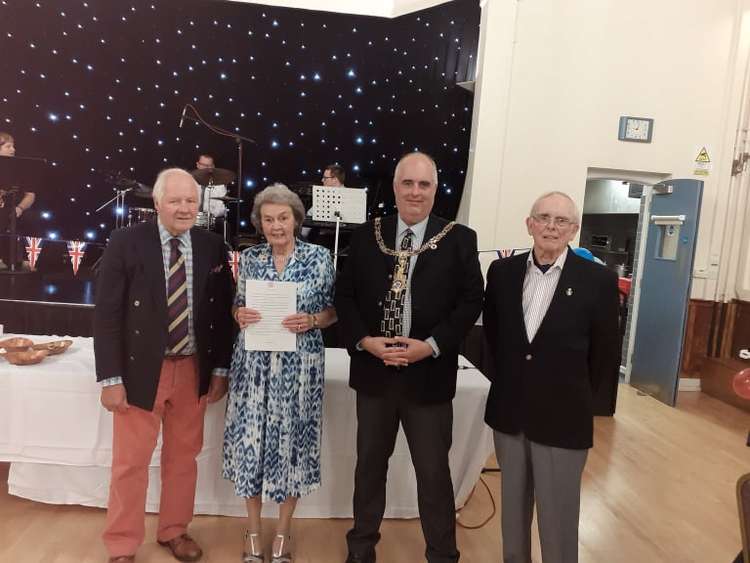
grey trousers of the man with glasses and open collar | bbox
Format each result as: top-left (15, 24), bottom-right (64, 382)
top-left (495, 432), bottom-right (588, 563)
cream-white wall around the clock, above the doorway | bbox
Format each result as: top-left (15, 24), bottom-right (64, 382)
top-left (459, 0), bottom-right (747, 299)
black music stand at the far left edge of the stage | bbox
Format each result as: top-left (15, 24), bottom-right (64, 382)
top-left (0, 156), bottom-right (47, 274)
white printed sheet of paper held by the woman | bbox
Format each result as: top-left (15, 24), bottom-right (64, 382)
top-left (245, 280), bottom-right (297, 352)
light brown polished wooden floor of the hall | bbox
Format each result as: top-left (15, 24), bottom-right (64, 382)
top-left (0, 386), bottom-right (750, 563)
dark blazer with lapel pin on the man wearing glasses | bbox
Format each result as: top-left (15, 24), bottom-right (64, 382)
top-left (483, 250), bottom-right (620, 449)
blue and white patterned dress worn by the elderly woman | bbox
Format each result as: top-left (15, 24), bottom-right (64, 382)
top-left (223, 239), bottom-right (335, 502)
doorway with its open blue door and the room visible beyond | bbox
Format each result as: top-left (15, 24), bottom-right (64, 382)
top-left (580, 169), bottom-right (703, 405)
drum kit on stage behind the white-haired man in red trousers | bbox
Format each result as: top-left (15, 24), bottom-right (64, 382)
top-left (97, 168), bottom-right (242, 240)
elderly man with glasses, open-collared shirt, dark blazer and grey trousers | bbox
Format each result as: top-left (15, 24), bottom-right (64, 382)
top-left (483, 192), bottom-right (619, 563)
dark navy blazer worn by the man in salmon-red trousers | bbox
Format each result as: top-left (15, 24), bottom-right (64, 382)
top-left (94, 223), bottom-right (233, 410)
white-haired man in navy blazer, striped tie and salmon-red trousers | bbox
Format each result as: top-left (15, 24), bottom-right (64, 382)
top-left (94, 168), bottom-right (233, 563)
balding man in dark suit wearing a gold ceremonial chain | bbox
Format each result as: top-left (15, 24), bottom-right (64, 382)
top-left (336, 153), bottom-right (483, 563)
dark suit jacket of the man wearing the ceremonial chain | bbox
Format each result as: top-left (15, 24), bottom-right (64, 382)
top-left (336, 215), bottom-right (483, 404)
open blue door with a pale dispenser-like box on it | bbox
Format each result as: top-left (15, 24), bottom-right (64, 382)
top-left (630, 180), bottom-right (703, 406)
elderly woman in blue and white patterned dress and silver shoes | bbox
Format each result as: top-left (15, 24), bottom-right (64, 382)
top-left (223, 184), bottom-right (336, 563)
